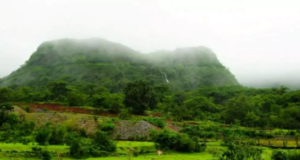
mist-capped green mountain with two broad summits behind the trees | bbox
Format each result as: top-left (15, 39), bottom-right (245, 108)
top-left (0, 38), bottom-right (238, 92)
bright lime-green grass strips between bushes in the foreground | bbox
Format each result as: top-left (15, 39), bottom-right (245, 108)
top-left (0, 141), bottom-right (284, 160)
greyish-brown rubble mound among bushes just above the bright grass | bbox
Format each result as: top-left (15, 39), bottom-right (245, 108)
top-left (113, 120), bottom-right (159, 140)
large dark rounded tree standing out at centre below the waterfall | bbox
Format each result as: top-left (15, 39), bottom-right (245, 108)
top-left (123, 80), bottom-right (158, 114)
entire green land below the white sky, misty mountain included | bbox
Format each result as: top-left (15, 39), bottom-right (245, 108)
top-left (0, 40), bottom-right (300, 160)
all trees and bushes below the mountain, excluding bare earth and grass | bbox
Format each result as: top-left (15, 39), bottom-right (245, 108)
top-left (0, 80), bottom-right (300, 160)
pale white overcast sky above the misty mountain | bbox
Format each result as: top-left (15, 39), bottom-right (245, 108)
top-left (0, 0), bottom-right (300, 84)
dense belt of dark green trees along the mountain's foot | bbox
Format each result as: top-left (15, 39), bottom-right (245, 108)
top-left (0, 80), bottom-right (300, 129)
